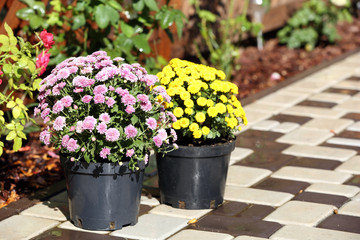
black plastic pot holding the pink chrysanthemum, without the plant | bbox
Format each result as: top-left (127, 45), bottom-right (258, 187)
top-left (61, 156), bottom-right (144, 230)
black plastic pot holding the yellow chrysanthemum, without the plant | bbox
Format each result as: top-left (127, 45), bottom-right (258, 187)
top-left (157, 141), bottom-right (235, 209)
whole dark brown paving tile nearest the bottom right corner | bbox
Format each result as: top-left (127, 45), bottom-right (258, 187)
top-left (293, 192), bottom-right (349, 208)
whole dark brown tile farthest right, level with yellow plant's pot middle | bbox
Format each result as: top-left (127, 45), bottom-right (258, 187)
top-left (288, 157), bottom-right (341, 170)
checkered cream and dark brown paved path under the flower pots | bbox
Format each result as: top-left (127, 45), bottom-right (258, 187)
top-left (0, 53), bottom-right (360, 240)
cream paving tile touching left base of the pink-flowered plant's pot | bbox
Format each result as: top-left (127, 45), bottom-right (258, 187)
top-left (20, 202), bottom-right (67, 221)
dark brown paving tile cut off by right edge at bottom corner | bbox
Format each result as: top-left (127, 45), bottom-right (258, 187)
top-left (317, 214), bottom-right (360, 233)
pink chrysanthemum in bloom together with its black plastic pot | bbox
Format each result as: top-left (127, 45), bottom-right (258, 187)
top-left (35, 51), bottom-right (176, 230)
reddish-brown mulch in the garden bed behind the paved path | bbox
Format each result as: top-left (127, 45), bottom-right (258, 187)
top-left (0, 18), bottom-right (360, 208)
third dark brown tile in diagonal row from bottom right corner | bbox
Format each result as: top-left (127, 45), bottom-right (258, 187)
top-left (252, 178), bottom-right (310, 195)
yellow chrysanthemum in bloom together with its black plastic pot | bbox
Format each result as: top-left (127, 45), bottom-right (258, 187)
top-left (157, 59), bottom-right (247, 209)
